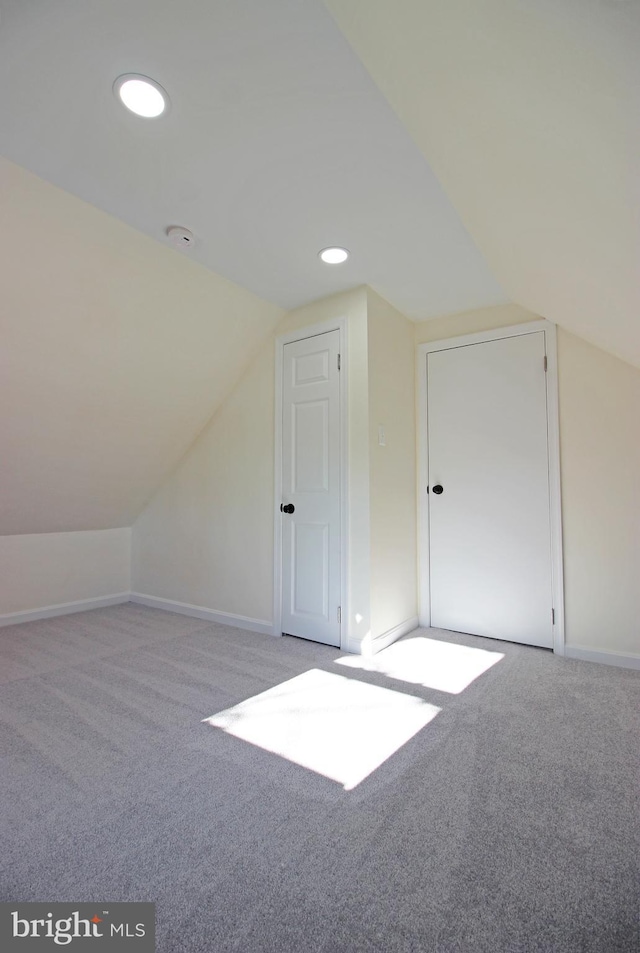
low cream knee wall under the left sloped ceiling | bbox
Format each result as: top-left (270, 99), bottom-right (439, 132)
top-left (0, 529), bottom-right (131, 621)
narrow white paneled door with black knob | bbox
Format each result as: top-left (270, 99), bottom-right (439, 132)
top-left (281, 331), bottom-right (341, 646)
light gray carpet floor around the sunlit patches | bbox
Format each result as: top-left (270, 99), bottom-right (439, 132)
top-left (0, 605), bottom-right (640, 953)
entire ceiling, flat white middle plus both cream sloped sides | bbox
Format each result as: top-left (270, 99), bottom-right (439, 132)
top-left (0, 0), bottom-right (640, 534)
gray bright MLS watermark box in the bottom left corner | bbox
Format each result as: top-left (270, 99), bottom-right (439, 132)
top-left (0, 903), bottom-right (156, 953)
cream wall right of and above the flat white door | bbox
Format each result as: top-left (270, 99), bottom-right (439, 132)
top-left (415, 305), bottom-right (640, 654)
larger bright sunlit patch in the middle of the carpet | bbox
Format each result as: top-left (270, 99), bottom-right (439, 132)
top-left (204, 669), bottom-right (441, 791)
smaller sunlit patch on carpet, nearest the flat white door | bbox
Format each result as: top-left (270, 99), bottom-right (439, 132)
top-left (336, 636), bottom-right (504, 695)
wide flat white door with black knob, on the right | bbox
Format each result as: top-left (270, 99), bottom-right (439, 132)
top-left (427, 331), bottom-right (553, 647)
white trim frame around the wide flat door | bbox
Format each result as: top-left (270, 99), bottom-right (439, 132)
top-left (416, 319), bottom-right (565, 655)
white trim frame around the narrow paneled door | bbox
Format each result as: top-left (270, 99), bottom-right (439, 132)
top-left (273, 317), bottom-right (349, 650)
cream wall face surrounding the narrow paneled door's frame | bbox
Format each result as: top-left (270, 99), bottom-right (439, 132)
top-left (133, 288), bottom-right (370, 640)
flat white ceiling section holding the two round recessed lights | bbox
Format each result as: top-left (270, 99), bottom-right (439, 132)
top-left (0, 0), bottom-right (506, 318)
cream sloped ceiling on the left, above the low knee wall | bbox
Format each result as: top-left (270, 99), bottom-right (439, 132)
top-left (0, 159), bottom-right (283, 535)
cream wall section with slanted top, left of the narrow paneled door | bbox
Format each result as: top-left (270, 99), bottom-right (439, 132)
top-left (132, 345), bottom-right (274, 622)
